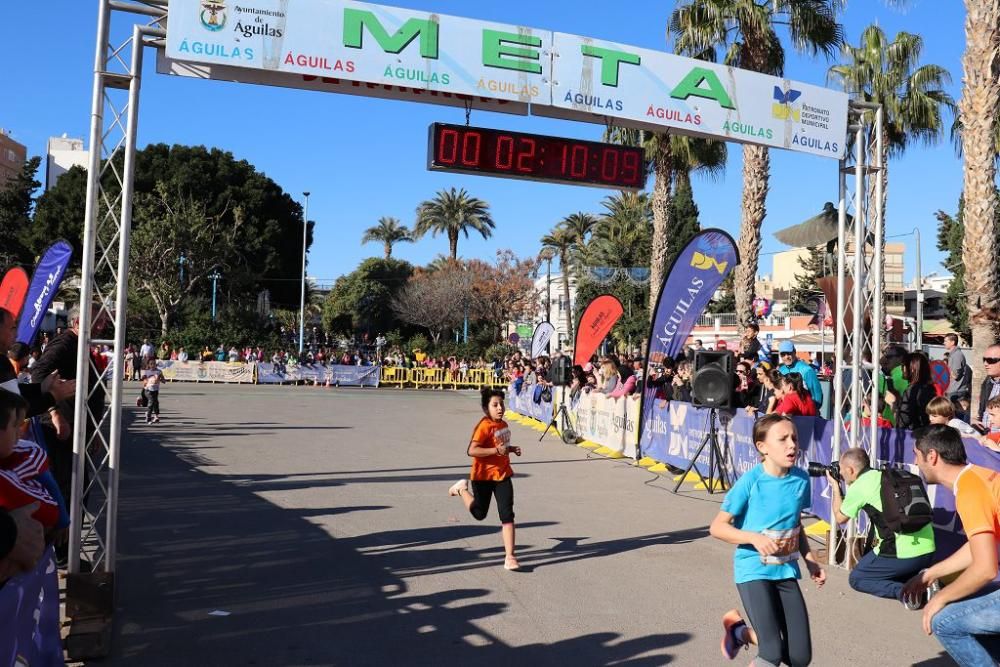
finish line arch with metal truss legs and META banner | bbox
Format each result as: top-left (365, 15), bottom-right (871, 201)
top-left (67, 0), bottom-right (885, 652)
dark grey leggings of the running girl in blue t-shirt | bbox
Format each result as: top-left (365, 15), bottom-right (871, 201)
top-left (736, 579), bottom-right (812, 667)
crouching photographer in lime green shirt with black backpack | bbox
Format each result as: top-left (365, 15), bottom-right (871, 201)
top-left (824, 448), bottom-right (934, 609)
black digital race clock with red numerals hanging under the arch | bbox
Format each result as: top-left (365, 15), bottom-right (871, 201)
top-left (428, 123), bottom-right (646, 190)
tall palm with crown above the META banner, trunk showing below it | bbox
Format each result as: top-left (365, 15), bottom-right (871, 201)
top-left (670, 0), bottom-right (844, 323)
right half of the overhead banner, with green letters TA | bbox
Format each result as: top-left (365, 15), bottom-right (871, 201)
top-left (548, 32), bottom-right (848, 159)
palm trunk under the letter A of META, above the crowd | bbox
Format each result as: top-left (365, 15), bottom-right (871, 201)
top-left (733, 144), bottom-right (771, 325)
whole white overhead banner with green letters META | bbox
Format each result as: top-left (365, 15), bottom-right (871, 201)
top-left (158, 0), bottom-right (848, 159)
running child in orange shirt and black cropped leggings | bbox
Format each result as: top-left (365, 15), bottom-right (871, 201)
top-left (448, 388), bottom-right (521, 570)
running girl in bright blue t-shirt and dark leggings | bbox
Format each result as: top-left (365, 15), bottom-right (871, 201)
top-left (709, 414), bottom-right (826, 667)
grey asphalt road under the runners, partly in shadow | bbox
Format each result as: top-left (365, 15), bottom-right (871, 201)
top-left (107, 384), bottom-right (952, 667)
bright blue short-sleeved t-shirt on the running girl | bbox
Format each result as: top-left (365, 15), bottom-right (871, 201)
top-left (722, 463), bottom-right (811, 584)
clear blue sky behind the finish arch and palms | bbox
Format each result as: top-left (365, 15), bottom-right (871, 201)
top-left (0, 0), bottom-right (965, 281)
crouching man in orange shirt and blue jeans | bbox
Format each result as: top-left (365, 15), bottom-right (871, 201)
top-left (903, 426), bottom-right (1000, 666)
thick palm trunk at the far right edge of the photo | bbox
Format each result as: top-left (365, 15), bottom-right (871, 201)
top-left (959, 0), bottom-right (1000, 405)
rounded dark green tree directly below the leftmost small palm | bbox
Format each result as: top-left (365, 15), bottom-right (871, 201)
top-left (322, 258), bottom-right (413, 337)
